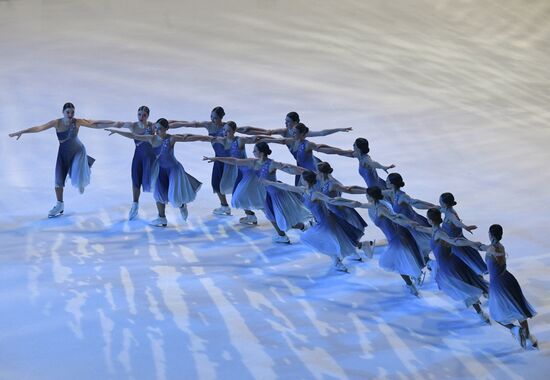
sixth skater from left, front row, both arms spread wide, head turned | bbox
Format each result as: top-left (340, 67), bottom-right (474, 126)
top-left (203, 142), bottom-right (312, 243)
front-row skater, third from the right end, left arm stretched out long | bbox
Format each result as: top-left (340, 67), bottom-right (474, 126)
top-left (319, 187), bottom-right (424, 296)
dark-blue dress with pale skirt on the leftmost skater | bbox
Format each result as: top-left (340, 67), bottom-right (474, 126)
top-left (55, 119), bottom-right (95, 194)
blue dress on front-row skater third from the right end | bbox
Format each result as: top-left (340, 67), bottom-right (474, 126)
top-left (369, 201), bottom-right (424, 278)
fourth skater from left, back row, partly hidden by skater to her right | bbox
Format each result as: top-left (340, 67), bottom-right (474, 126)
top-left (170, 106), bottom-right (240, 215)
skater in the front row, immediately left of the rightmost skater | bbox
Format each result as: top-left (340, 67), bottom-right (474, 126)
top-left (410, 208), bottom-right (492, 324)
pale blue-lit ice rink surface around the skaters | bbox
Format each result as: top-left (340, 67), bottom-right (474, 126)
top-left (0, 0), bottom-right (550, 380)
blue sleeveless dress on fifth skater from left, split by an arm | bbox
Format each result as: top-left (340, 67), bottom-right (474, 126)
top-left (229, 137), bottom-right (266, 210)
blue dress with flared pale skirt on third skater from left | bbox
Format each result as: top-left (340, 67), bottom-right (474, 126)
top-left (151, 136), bottom-right (202, 208)
